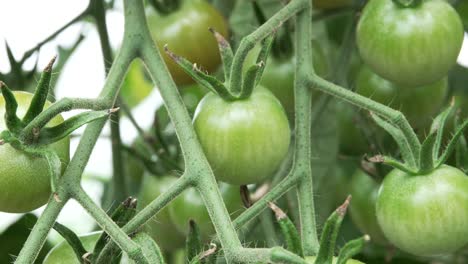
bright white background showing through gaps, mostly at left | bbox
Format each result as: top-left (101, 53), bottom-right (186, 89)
top-left (0, 0), bottom-right (468, 243)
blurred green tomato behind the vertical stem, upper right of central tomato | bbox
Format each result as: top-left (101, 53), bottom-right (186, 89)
top-left (260, 41), bottom-right (328, 118)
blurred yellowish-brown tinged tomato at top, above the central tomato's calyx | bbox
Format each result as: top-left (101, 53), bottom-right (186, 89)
top-left (148, 0), bottom-right (228, 85)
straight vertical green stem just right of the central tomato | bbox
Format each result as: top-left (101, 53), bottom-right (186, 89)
top-left (293, 0), bottom-right (319, 256)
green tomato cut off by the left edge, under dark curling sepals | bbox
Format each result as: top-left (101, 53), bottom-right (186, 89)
top-left (0, 91), bottom-right (70, 213)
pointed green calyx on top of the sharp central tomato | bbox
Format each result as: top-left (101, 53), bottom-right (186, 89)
top-left (164, 25), bottom-right (274, 101)
